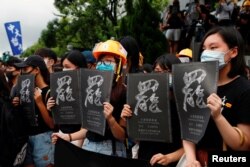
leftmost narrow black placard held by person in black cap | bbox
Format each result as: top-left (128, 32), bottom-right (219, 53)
top-left (17, 75), bottom-right (38, 126)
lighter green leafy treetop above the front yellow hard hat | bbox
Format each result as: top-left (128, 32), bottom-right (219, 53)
top-left (51, 0), bottom-right (123, 48)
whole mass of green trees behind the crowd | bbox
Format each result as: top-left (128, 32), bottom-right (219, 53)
top-left (22, 0), bottom-right (168, 63)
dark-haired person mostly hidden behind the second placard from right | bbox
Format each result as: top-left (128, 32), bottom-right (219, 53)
top-left (121, 54), bottom-right (184, 167)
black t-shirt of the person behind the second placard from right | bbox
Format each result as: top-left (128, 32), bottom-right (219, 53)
top-left (138, 93), bottom-right (182, 167)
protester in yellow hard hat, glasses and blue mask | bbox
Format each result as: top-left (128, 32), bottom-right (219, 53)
top-left (52, 40), bottom-right (127, 157)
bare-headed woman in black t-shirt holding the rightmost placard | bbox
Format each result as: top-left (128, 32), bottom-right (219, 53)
top-left (183, 27), bottom-right (250, 167)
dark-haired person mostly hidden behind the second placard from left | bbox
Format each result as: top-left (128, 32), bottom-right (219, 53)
top-left (47, 50), bottom-right (87, 147)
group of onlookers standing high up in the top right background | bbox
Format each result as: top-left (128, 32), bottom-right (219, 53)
top-left (160, 0), bottom-right (250, 54)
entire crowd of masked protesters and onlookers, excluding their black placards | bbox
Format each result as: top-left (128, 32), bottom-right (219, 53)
top-left (0, 0), bottom-right (250, 167)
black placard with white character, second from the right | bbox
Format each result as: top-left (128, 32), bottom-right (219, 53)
top-left (127, 73), bottom-right (172, 142)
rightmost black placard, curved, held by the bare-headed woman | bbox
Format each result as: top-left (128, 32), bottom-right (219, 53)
top-left (172, 61), bottom-right (218, 143)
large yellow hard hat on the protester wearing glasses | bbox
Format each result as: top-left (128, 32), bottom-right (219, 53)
top-left (93, 40), bottom-right (127, 65)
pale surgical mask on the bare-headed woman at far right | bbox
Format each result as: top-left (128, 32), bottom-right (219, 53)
top-left (201, 50), bottom-right (228, 69)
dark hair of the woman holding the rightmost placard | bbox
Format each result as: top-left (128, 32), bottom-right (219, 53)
top-left (199, 26), bottom-right (246, 78)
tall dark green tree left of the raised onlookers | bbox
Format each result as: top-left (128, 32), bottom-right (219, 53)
top-left (120, 0), bottom-right (167, 63)
